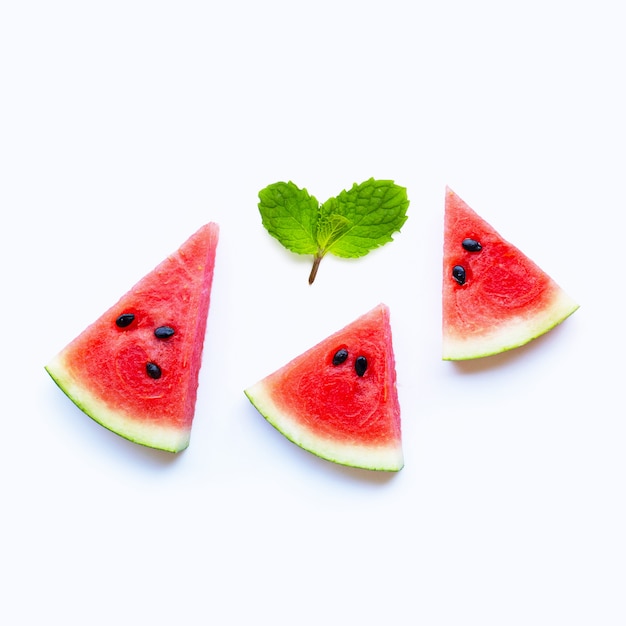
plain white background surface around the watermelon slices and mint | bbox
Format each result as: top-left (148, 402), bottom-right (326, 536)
top-left (0, 0), bottom-right (626, 626)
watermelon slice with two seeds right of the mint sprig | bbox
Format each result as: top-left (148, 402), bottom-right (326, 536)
top-left (442, 188), bottom-right (578, 360)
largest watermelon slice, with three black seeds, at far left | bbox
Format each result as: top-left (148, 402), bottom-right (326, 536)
top-left (46, 223), bottom-right (219, 452)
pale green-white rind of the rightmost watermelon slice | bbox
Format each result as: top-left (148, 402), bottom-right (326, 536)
top-left (442, 287), bottom-right (579, 361)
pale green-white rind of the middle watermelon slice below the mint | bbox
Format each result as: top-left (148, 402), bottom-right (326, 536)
top-left (244, 380), bottom-right (404, 472)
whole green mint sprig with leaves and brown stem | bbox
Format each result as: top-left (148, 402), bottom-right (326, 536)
top-left (259, 178), bottom-right (409, 284)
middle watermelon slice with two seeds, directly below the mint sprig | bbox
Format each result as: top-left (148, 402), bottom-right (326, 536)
top-left (244, 304), bottom-right (404, 471)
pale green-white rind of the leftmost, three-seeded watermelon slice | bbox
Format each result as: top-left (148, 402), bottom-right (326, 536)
top-left (45, 352), bottom-right (191, 452)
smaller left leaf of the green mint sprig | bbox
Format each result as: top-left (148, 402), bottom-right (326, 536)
top-left (259, 182), bottom-right (319, 254)
